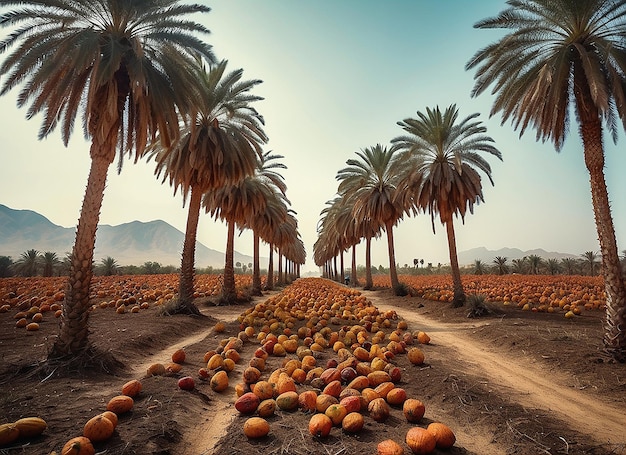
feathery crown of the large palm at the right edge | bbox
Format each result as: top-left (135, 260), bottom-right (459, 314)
top-left (467, 0), bottom-right (626, 148)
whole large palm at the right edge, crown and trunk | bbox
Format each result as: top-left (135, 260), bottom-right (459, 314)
top-left (466, 0), bottom-right (626, 361)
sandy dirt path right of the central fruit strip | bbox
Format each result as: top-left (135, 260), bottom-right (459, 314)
top-left (363, 291), bottom-right (626, 453)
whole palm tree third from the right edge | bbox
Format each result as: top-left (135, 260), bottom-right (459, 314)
top-left (336, 144), bottom-right (405, 291)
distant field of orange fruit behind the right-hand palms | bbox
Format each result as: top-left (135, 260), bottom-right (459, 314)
top-left (373, 275), bottom-right (606, 314)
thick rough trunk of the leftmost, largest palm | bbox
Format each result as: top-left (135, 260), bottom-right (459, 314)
top-left (48, 155), bottom-right (111, 359)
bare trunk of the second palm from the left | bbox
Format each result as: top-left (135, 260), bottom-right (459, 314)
top-left (174, 186), bottom-right (202, 315)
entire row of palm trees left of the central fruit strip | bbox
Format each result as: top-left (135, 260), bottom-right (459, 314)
top-left (0, 0), bottom-right (306, 360)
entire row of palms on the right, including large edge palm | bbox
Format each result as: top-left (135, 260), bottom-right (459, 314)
top-left (315, 0), bottom-right (626, 362)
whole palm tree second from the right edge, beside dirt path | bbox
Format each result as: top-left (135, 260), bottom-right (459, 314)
top-left (392, 105), bottom-right (502, 307)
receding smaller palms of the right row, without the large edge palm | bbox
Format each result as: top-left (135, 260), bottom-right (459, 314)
top-left (314, 105), bottom-right (502, 307)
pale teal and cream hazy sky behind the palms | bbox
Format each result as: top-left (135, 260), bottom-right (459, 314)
top-left (0, 0), bottom-right (626, 271)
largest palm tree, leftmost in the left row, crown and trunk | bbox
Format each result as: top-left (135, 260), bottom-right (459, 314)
top-left (0, 0), bottom-right (214, 358)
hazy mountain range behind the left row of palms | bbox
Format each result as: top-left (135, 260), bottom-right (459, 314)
top-left (0, 204), bottom-right (258, 268)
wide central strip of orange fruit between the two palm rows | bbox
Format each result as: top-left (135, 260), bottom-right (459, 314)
top-left (223, 279), bottom-right (456, 454)
